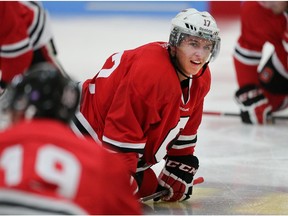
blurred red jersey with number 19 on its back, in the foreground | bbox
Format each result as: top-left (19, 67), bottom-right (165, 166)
top-left (0, 119), bottom-right (141, 215)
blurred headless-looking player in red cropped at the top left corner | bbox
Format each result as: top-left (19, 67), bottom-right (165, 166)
top-left (0, 1), bottom-right (66, 95)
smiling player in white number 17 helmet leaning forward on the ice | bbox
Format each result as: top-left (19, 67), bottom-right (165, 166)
top-left (78, 8), bottom-right (220, 201)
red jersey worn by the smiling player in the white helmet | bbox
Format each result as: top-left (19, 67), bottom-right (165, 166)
top-left (81, 42), bottom-right (211, 172)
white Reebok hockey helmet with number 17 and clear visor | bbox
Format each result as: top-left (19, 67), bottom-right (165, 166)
top-left (169, 8), bottom-right (221, 61)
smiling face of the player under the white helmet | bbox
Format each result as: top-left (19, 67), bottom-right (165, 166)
top-left (176, 36), bottom-right (213, 76)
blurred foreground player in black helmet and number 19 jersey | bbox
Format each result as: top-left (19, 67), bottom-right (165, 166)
top-left (0, 63), bottom-right (141, 215)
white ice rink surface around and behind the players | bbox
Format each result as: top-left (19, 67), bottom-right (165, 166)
top-left (1, 13), bottom-right (288, 215)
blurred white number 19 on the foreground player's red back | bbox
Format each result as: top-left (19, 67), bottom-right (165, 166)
top-left (0, 144), bottom-right (81, 198)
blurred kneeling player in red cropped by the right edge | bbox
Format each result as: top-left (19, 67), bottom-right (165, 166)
top-left (234, 1), bottom-right (288, 124)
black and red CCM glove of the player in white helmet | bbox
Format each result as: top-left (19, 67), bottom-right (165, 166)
top-left (158, 155), bottom-right (199, 202)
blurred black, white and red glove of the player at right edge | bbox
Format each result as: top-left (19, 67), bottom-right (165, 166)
top-left (235, 85), bottom-right (272, 124)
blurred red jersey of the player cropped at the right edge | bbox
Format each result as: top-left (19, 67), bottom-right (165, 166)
top-left (234, 2), bottom-right (288, 111)
